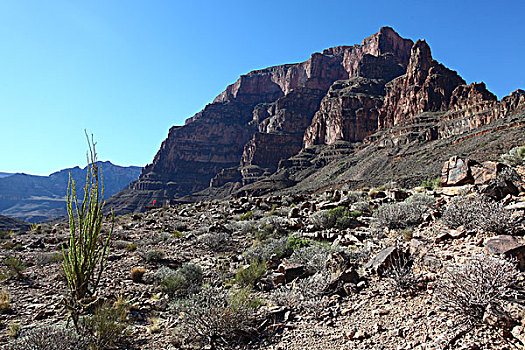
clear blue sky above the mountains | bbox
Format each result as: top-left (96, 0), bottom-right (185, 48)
top-left (0, 0), bottom-right (525, 175)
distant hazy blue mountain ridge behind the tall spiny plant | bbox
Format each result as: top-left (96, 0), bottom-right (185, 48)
top-left (0, 162), bottom-right (140, 222)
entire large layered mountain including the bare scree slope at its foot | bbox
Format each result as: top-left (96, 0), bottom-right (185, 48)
top-left (109, 27), bottom-right (525, 213)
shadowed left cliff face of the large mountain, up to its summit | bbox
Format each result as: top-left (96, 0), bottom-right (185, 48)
top-left (114, 28), bottom-right (418, 208)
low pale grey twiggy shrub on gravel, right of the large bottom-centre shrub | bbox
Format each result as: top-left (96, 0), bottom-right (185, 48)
top-left (270, 272), bottom-right (331, 318)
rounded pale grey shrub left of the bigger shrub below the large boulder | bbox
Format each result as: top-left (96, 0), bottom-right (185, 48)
top-left (374, 202), bottom-right (426, 229)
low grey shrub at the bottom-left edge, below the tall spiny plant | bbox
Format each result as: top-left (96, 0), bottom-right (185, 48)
top-left (5, 326), bottom-right (90, 350)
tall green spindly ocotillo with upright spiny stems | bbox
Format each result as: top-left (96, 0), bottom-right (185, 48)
top-left (63, 133), bottom-right (114, 308)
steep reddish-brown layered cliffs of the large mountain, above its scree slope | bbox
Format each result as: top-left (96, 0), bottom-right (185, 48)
top-left (110, 27), bottom-right (525, 211)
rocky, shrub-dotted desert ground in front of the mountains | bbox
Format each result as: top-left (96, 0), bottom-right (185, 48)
top-left (0, 151), bottom-right (525, 349)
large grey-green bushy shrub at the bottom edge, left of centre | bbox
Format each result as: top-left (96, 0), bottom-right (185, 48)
top-left (172, 286), bottom-right (256, 349)
